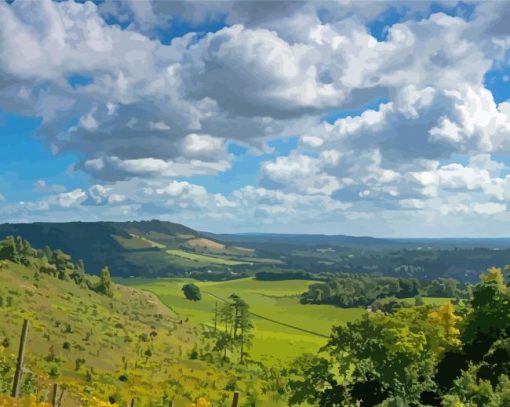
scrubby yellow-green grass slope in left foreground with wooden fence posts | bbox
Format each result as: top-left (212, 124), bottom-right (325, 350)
top-left (0, 237), bottom-right (286, 407)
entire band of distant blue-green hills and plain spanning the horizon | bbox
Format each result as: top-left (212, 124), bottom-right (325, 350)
top-left (0, 220), bottom-right (510, 282)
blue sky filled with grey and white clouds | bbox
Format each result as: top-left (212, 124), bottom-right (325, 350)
top-left (0, 0), bottom-right (510, 237)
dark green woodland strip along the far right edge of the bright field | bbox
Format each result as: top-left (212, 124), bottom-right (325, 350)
top-left (301, 274), bottom-right (463, 308)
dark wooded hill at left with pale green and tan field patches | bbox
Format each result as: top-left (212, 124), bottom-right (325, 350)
top-left (0, 220), bottom-right (258, 277)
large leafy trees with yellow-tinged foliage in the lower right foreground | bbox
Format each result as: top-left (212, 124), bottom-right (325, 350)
top-left (288, 268), bottom-right (510, 407)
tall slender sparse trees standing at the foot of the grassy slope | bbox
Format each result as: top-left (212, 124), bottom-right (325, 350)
top-left (210, 294), bottom-right (253, 363)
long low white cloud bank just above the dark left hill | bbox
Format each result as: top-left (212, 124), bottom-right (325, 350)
top-left (0, 179), bottom-right (351, 225)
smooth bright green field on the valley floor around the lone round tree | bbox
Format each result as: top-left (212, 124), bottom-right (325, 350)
top-left (121, 278), bottom-right (365, 364)
